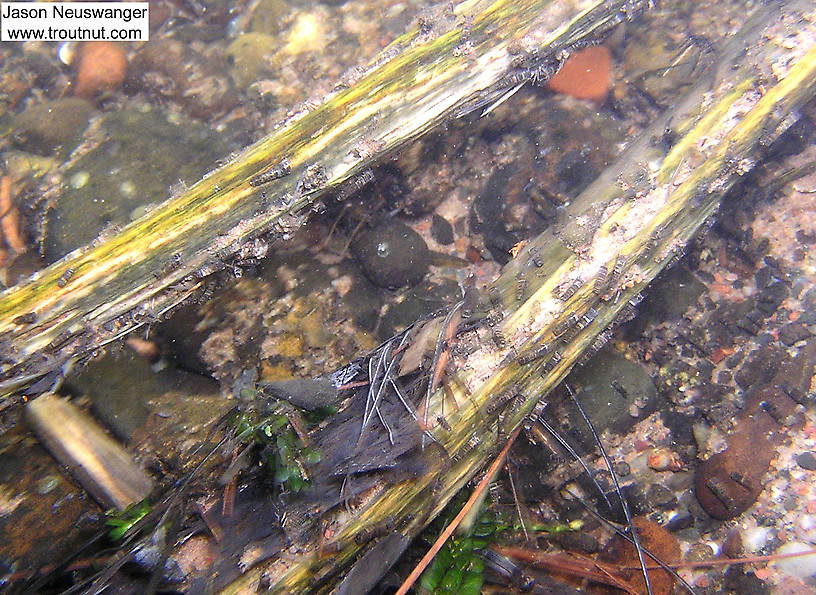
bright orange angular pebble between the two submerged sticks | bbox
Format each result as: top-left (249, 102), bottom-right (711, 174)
top-left (547, 45), bottom-right (612, 103)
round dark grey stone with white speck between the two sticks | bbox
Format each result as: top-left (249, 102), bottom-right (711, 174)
top-left (351, 221), bottom-right (430, 288)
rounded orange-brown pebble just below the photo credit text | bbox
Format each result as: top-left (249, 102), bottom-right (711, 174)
top-left (74, 41), bottom-right (127, 99)
